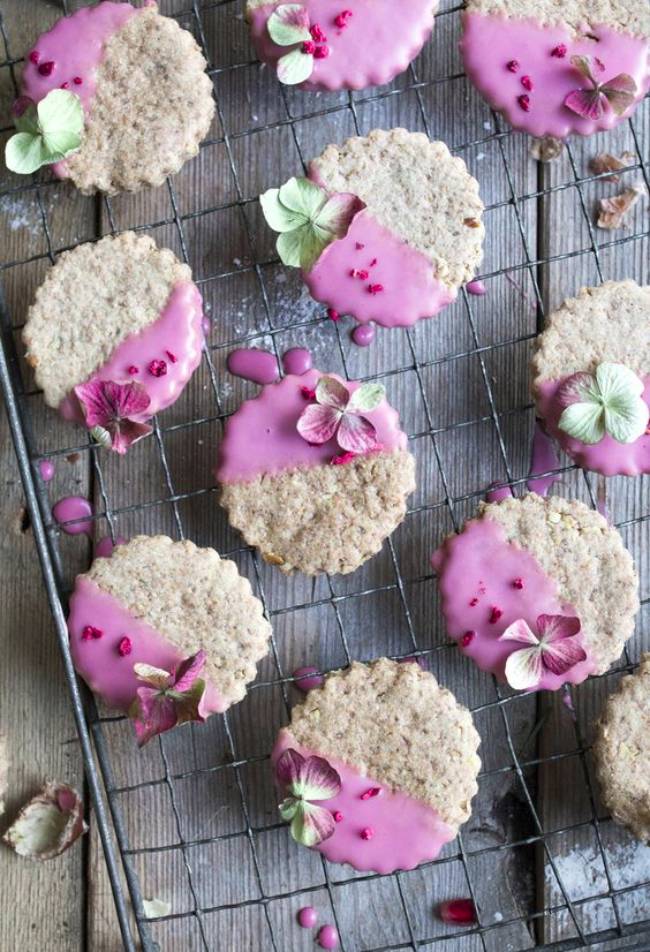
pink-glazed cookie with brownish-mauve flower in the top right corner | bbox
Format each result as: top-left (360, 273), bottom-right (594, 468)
top-left (460, 0), bottom-right (650, 139)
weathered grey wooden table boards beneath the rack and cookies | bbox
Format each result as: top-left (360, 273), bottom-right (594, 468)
top-left (0, 0), bottom-right (650, 952)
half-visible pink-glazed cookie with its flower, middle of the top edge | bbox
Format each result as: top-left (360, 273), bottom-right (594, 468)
top-left (246, 0), bottom-right (438, 90)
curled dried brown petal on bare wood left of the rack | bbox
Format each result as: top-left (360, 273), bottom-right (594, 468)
top-left (3, 783), bottom-right (88, 860)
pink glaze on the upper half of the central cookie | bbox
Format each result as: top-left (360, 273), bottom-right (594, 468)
top-left (216, 369), bottom-right (406, 483)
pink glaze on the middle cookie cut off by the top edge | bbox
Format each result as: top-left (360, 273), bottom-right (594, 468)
top-left (250, 0), bottom-right (435, 90)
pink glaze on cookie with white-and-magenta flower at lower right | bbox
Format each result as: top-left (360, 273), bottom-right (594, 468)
top-left (431, 519), bottom-right (595, 691)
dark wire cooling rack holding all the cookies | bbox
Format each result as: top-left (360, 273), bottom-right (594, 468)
top-left (0, 0), bottom-right (650, 952)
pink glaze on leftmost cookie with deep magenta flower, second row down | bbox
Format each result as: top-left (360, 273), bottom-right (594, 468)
top-left (59, 281), bottom-right (203, 423)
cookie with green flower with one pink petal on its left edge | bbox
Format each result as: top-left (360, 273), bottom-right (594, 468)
top-left (260, 129), bottom-right (484, 327)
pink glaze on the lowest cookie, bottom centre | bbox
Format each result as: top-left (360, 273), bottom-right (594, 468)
top-left (271, 728), bottom-right (456, 874)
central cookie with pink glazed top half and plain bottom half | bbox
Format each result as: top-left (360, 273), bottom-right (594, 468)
top-left (216, 369), bottom-right (415, 575)
